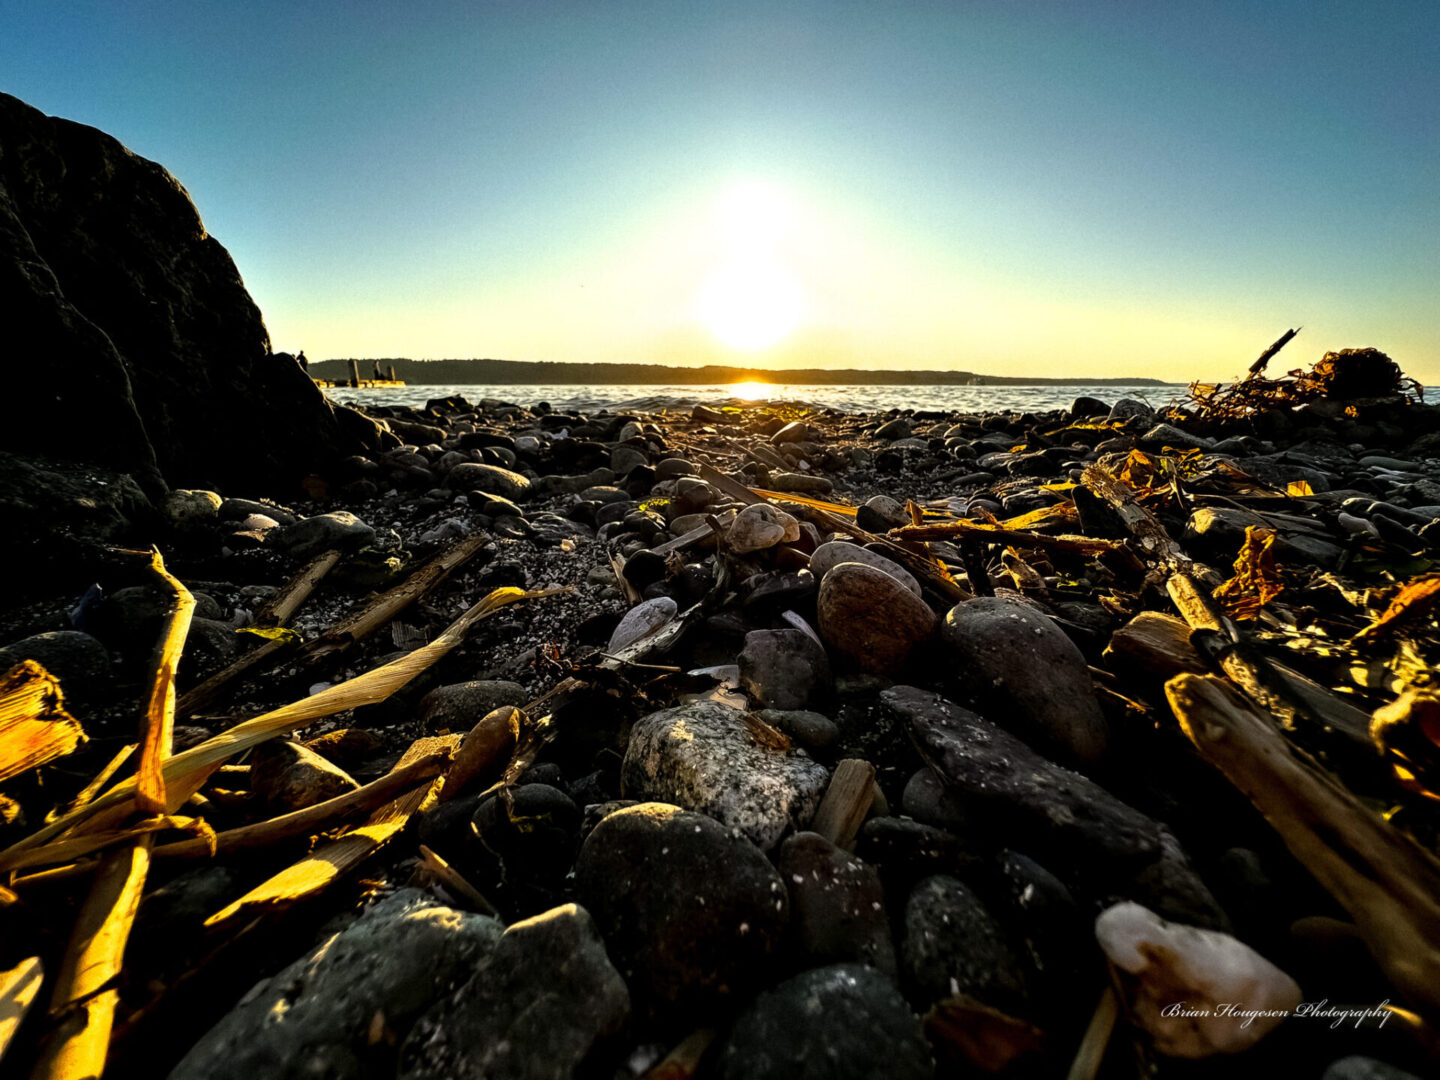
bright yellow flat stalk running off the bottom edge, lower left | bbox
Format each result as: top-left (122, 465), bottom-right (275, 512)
top-left (30, 837), bottom-right (151, 1080)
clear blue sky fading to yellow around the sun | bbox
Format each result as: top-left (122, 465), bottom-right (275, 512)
top-left (0, 0), bottom-right (1440, 384)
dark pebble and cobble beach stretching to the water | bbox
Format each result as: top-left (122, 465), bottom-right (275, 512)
top-left (0, 377), bottom-right (1440, 1080)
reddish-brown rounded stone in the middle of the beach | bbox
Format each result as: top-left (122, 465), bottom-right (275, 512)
top-left (816, 563), bottom-right (937, 675)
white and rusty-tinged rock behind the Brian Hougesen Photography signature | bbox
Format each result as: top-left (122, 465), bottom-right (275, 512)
top-left (1094, 901), bottom-right (1300, 1058)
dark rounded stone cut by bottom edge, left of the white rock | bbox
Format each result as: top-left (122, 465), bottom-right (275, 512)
top-left (720, 963), bottom-right (935, 1080)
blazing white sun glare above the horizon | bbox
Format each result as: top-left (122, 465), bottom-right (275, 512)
top-left (696, 181), bottom-right (808, 351)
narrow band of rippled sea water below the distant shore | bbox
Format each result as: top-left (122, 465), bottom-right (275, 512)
top-left (327, 383), bottom-right (1185, 412)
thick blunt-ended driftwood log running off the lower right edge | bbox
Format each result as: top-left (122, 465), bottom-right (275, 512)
top-left (1165, 675), bottom-right (1440, 1024)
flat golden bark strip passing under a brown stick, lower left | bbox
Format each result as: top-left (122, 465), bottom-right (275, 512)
top-left (204, 734), bottom-right (459, 930)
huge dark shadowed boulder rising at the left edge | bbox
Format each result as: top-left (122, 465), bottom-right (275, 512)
top-left (0, 94), bottom-right (354, 494)
